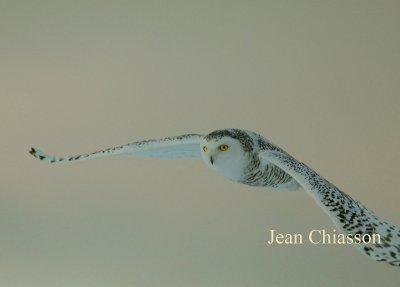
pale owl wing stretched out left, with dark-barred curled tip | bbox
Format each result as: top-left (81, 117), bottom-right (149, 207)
top-left (29, 134), bottom-right (203, 163)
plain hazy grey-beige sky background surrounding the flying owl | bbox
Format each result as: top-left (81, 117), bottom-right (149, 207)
top-left (0, 0), bottom-right (400, 287)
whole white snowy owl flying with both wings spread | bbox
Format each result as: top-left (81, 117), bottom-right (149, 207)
top-left (30, 129), bottom-right (400, 266)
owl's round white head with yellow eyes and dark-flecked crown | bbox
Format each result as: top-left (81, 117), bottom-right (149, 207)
top-left (200, 129), bottom-right (253, 180)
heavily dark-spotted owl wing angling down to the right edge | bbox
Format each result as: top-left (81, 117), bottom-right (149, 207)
top-left (260, 150), bottom-right (400, 266)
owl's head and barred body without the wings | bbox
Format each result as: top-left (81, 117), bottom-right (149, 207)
top-left (201, 129), bottom-right (300, 190)
